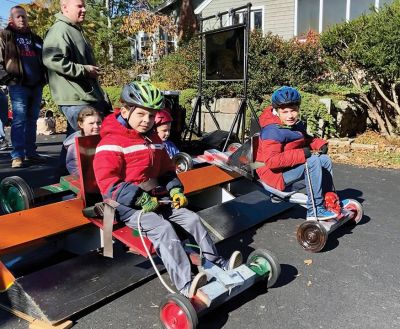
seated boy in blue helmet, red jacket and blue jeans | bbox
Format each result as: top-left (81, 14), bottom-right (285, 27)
top-left (257, 86), bottom-right (337, 220)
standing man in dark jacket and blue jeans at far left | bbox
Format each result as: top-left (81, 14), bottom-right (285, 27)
top-left (0, 6), bottom-right (45, 168)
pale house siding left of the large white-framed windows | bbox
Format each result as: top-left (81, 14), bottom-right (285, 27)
top-left (202, 0), bottom-right (295, 39)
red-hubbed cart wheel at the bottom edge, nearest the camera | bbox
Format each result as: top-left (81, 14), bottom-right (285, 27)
top-left (160, 294), bottom-right (199, 329)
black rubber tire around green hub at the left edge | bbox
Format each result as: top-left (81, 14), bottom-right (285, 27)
top-left (0, 176), bottom-right (35, 214)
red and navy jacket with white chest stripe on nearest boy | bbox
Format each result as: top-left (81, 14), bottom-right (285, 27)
top-left (93, 112), bottom-right (182, 220)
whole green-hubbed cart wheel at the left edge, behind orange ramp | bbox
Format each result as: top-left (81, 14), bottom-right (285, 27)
top-left (0, 176), bottom-right (34, 214)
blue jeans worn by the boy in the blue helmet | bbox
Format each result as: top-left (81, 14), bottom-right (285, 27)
top-left (283, 154), bottom-right (333, 210)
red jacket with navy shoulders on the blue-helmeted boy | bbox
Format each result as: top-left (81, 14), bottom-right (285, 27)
top-left (256, 106), bottom-right (327, 191)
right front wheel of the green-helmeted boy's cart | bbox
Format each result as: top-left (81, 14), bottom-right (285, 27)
top-left (246, 249), bottom-right (281, 288)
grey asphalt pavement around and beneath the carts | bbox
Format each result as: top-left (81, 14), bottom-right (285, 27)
top-left (0, 134), bottom-right (400, 329)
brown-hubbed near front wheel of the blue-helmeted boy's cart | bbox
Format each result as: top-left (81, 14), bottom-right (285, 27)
top-left (297, 220), bottom-right (328, 252)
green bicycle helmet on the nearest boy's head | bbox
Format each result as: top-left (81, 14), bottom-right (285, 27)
top-left (121, 81), bottom-right (164, 110)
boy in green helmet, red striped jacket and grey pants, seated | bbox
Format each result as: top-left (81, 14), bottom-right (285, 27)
top-left (93, 82), bottom-right (241, 298)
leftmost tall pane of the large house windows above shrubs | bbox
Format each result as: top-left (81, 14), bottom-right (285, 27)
top-left (297, 0), bottom-right (320, 35)
